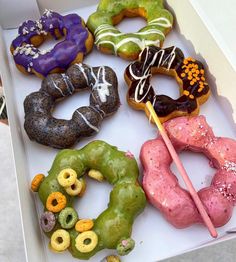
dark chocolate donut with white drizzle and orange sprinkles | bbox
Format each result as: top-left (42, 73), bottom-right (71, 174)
top-left (125, 46), bottom-right (210, 122)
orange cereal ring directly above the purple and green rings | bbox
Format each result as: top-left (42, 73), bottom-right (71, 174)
top-left (46, 192), bottom-right (67, 213)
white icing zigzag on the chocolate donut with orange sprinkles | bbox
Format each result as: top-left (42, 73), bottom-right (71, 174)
top-left (129, 47), bottom-right (176, 103)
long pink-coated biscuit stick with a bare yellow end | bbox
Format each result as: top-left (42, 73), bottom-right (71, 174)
top-left (146, 101), bottom-right (218, 238)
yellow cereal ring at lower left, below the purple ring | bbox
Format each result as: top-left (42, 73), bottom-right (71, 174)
top-left (50, 229), bottom-right (70, 252)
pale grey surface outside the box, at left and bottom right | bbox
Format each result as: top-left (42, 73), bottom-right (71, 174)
top-left (0, 124), bottom-right (236, 262)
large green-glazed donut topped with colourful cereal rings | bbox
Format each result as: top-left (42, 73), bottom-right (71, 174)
top-left (31, 141), bottom-right (146, 259)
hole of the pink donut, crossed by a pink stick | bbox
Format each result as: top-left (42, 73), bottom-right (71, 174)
top-left (170, 151), bottom-right (215, 190)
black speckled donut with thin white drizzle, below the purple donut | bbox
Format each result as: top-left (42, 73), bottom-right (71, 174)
top-left (24, 64), bottom-right (120, 148)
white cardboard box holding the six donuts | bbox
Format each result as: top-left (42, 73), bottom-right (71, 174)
top-left (0, 0), bottom-right (236, 262)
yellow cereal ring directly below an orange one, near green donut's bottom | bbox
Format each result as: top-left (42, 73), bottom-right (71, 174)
top-left (75, 230), bottom-right (98, 253)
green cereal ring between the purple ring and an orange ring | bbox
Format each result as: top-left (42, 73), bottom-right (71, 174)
top-left (58, 207), bottom-right (78, 229)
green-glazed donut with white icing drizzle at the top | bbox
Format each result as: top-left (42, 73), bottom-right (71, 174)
top-left (87, 0), bottom-right (173, 60)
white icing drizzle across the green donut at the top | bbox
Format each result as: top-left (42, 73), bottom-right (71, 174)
top-left (94, 17), bottom-right (172, 55)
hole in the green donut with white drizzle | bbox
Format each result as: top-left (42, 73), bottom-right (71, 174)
top-left (116, 15), bottom-right (147, 33)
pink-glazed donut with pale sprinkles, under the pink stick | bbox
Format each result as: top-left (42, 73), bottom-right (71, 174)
top-left (140, 116), bottom-right (236, 228)
